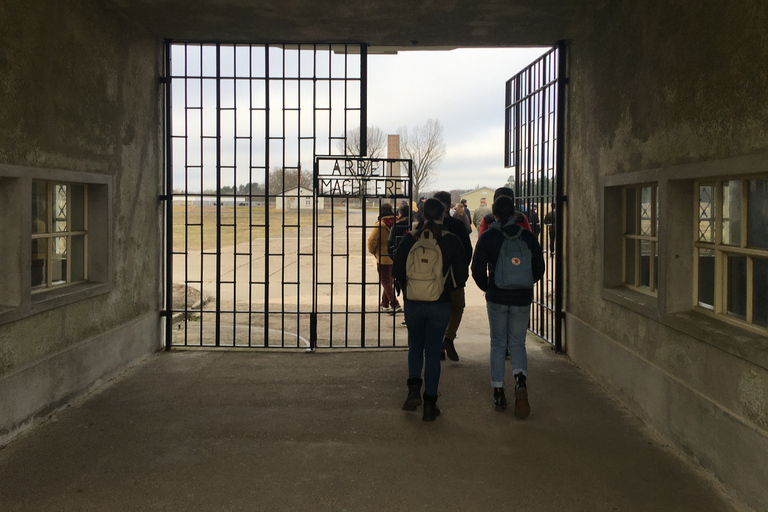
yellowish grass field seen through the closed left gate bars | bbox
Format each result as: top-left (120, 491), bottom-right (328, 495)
top-left (173, 205), bottom-right (344, 251)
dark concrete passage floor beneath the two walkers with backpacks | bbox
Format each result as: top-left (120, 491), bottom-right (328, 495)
top-left (0, 312), bottom-right (746, 512)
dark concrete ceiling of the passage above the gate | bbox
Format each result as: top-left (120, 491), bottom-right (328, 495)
top-left (102, 0), bottom-right (608, 51)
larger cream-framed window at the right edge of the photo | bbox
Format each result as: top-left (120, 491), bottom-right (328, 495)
top-left (694, 177), bottom-right (768, 328)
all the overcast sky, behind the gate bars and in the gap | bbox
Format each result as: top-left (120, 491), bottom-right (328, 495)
top-left (172, 45), bottom-right (549, 192)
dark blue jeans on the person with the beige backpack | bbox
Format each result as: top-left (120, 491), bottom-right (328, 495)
top-left (403, 300), bottom-right (451, 395)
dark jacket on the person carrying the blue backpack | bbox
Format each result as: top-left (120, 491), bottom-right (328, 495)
top-left (472, 220), bottom-right (546, 306)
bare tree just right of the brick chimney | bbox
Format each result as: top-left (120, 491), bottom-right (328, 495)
top-left (399, 119), bottom-right (445, 199)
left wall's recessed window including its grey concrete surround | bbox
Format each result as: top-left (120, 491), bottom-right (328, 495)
top-left (0, 164), bottom-right (113, 325)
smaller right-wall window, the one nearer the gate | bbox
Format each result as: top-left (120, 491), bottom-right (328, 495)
top-left (622, 185), bottom-right (659, 295)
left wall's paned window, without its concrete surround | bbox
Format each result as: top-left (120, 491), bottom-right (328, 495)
top-left (31, 181), bottom-right (88, 293)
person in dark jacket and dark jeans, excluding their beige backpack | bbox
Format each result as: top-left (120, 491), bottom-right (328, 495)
top-left (393, 199), bottom-right (468, 421)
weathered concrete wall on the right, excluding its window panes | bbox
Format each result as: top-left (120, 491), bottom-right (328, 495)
top-left (565, 0), bottom-right (768, 509)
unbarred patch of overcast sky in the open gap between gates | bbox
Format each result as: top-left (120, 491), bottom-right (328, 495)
top-left (368, 48), bottom-right (549, 194)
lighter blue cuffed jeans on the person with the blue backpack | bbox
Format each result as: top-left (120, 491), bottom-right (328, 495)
top-left (486, 302), bottom-right (531, 388)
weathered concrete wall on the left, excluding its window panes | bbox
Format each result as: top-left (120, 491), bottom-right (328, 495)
top-left (0, 0), bottom-right (162, 444)
